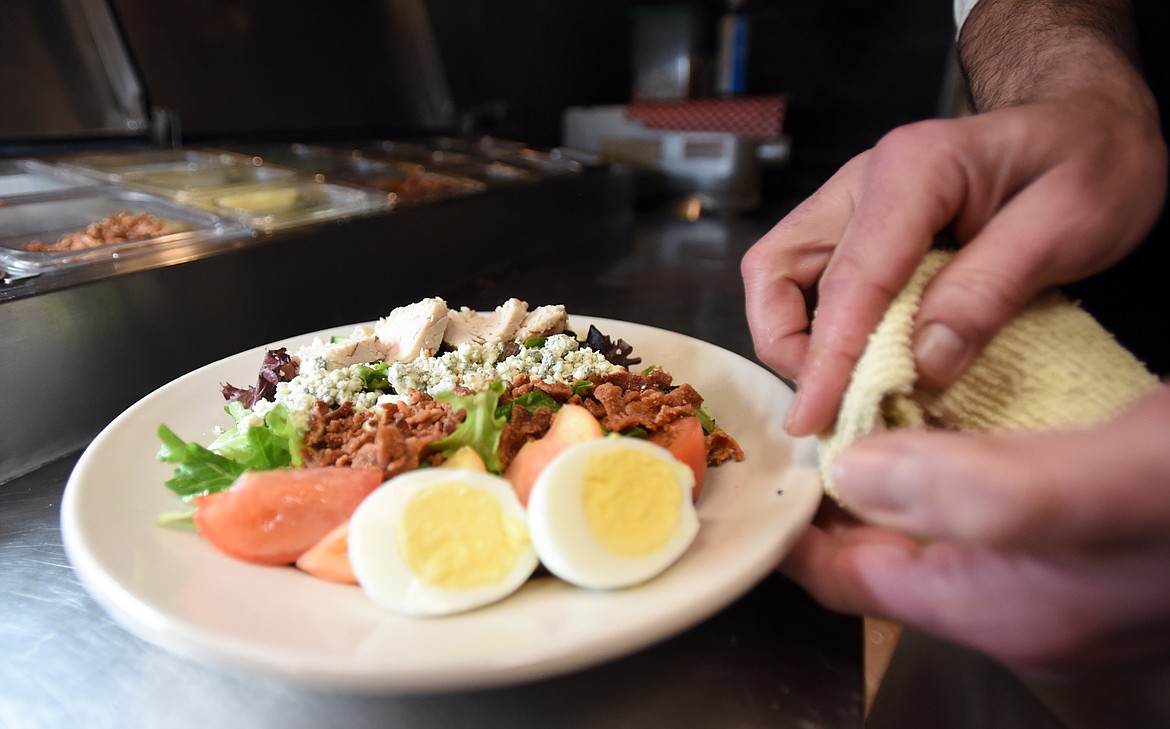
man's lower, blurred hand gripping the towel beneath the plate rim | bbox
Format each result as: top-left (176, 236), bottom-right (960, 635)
top-left (780, 387), bottom-right (1170, 675)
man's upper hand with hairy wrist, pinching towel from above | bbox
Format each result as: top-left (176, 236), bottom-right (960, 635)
top-left (742, 0), bottom-right (1166, 434)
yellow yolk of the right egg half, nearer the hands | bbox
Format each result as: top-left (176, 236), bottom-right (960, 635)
top-left (581, 451), bottom-right (682, 557)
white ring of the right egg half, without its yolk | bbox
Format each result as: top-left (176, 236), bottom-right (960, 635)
top-left (528, 436), bottom-right (698, 590)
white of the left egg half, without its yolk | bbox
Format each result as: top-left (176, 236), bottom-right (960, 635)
top-left (349, 468), bottom-right (538, 615)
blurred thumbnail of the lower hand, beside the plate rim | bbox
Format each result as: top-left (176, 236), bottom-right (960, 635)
top-left (833, 448), bottom-right (923, 515)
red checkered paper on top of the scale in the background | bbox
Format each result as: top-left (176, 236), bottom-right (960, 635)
top-left (626, 95), bottom-right (789, 139)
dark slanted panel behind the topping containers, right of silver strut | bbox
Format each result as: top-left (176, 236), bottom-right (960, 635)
top-left (110, 0), bottom-right (454, 138)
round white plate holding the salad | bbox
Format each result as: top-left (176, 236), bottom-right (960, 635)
top-left (61, 317), bottom-right (820, 692)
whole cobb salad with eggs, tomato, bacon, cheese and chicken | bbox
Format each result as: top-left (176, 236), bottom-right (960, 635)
top-left (158, 298), bottom-right (744, 615)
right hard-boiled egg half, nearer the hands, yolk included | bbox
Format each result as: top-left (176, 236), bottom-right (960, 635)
top-left (528, 435), bottom-right (698, 590)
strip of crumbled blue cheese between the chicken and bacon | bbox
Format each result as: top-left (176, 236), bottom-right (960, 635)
top-left (241, 335), bottom-right (621, 432)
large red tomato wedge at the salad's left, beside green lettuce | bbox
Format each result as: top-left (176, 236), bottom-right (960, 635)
top-left (195, 467), bottom-right (383, 564)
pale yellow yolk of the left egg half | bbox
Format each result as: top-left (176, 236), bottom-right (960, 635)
top-left (398, 483), bottom-right (528, 590)
